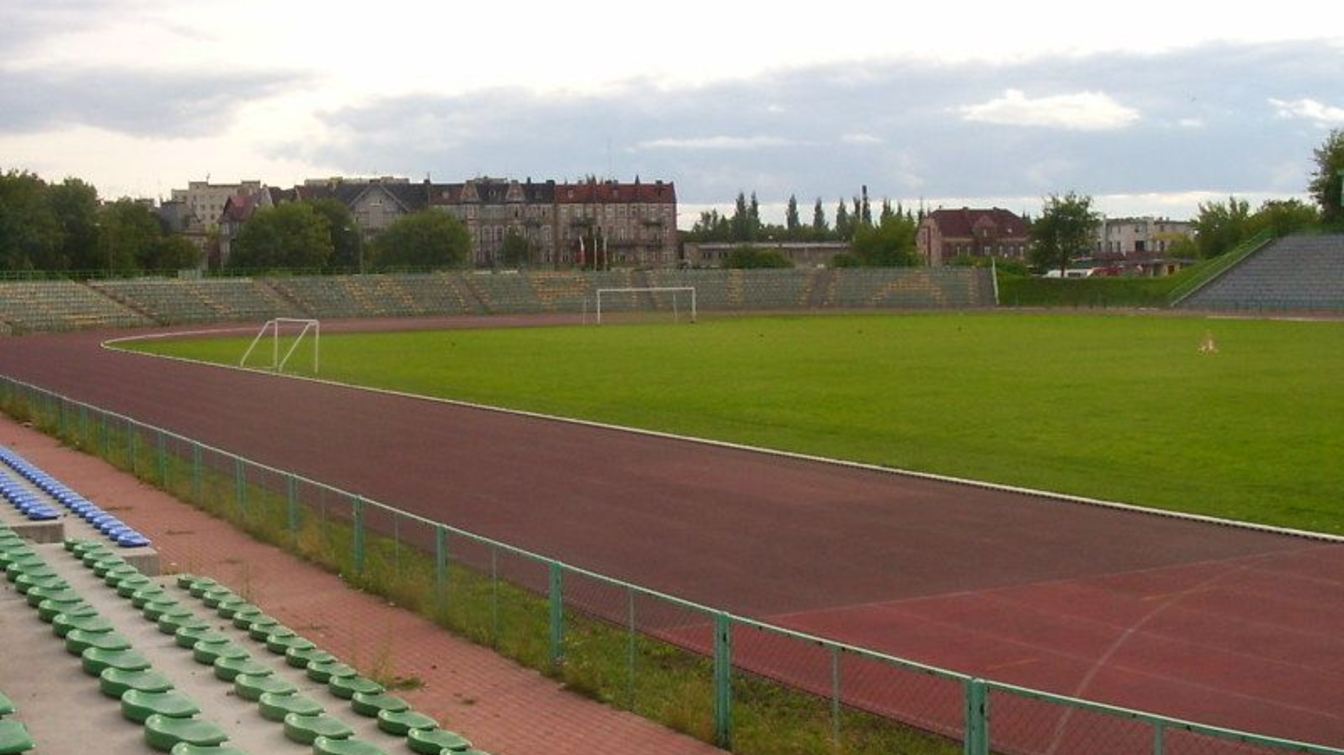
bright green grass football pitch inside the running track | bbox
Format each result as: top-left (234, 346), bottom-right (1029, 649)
top-left (130, 313), bottom-right (1344, 533)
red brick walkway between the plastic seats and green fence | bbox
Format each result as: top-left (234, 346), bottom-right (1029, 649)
top-left (0, 415), bottom-right (719, 755)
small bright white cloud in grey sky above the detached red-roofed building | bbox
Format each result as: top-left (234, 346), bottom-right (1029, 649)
top-left (958, 89), bottom-right (1138, 132)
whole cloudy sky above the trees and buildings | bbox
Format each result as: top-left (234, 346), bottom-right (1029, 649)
top-left (0, 0), bottom-right (1344, 226)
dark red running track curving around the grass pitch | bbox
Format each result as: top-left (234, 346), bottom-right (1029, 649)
top-left (0, 318), bottom-right (1344, 752)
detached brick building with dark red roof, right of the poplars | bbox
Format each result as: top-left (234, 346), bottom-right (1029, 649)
top-left (915, 207), bottom-right (1030, 267)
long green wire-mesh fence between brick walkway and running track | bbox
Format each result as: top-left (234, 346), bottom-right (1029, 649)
top-left (0, 376), bottom-right (1344, 755)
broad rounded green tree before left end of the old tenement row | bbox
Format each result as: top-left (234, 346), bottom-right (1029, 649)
top-left (226, 202), bottom-right (332, 270)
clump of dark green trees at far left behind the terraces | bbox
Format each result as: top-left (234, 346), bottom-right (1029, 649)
top-left (0, 171), bottom-right (200, 273)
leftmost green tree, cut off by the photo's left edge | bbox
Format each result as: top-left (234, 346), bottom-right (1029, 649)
top-left (0, 171), bottom-right (62, 270)
